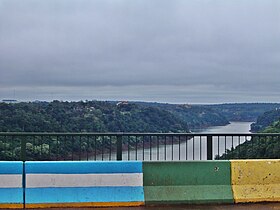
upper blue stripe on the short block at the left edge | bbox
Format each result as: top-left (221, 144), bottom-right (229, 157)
top-left (0, 161), bottom-right (23, 174)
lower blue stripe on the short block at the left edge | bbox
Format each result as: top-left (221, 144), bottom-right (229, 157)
top-left (0, 188), bottom-right (23, 204)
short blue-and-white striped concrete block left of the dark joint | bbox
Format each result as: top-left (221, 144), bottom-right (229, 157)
top-left (0, 161), bottom-right (23, 209)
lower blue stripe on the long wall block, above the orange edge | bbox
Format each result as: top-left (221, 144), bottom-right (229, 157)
top-left (25, 187), bottom-right (144, 204)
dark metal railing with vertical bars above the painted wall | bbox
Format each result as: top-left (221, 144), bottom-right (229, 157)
top-left (0, 133), bottom-right (280, 161)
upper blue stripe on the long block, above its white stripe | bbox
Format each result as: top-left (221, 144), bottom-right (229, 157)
top-left (25, 161), bottom-right (143, 174)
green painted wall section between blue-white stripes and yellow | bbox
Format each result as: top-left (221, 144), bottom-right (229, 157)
top-left (143, 161), bottom-right (234, 204)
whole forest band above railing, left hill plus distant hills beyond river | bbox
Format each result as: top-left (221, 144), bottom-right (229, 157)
top-left (0, 101), bottom-right (280, 132)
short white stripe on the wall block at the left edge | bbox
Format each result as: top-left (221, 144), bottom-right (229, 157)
top-left (0, 174), bottom-right (22, 188)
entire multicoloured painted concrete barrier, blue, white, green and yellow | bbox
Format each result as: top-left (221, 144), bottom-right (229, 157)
top-left (0, 160), bottom-right (280, 209)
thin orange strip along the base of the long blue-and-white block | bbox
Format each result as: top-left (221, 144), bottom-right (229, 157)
top-left (25, 202), bottom-right (144, 208)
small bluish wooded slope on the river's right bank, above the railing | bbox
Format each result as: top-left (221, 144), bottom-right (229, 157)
top-left (251, 108), bottom-right (280, 132)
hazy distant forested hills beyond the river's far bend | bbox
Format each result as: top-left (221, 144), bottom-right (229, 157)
top-left (138, 102), bottom-right (280, 124)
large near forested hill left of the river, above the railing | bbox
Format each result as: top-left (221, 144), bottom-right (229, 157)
top-left (0, 101), bottom-right (188, 132)
